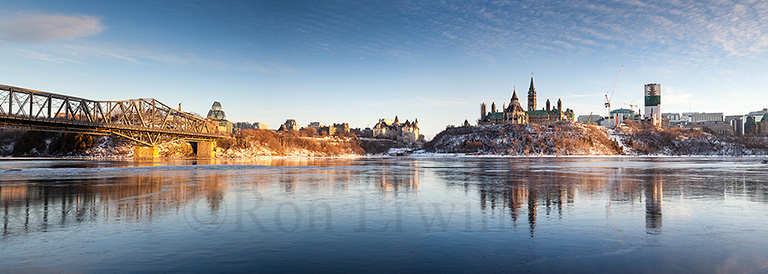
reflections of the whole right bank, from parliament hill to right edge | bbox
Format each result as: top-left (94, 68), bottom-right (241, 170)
top-left (428, 159), bottom-right (768, 237)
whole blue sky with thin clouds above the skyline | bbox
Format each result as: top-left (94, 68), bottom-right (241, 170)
top-left (0, 0), bottom-right (768, 139)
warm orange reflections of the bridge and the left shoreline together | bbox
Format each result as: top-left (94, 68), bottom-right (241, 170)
top-left (0, 160), bottom-right (421, 235)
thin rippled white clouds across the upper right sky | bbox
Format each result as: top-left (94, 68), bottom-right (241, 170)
top-left (390, 0), bottom-right (768, 63)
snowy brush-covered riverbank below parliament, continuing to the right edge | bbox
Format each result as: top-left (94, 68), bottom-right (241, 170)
top-left (424, 122), bottom-right (768, 156)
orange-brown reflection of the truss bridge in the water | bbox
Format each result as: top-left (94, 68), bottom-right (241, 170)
top-left (0, 170), bottom-right (228, 235)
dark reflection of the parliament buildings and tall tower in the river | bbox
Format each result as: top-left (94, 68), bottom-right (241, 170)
top-left (438, 164), bottom-right (672, 237)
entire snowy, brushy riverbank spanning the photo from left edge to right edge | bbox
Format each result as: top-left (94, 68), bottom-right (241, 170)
top-left (0, 122), bottom-right (768, 160)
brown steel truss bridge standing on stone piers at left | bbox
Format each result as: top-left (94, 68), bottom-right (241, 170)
top-left (0, 82), bottom-right (226, 157)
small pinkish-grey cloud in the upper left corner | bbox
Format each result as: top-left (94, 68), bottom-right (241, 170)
top-left (0, 14), bottom-right (107, 44)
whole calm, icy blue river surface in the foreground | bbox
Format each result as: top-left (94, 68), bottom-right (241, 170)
top-left (0, 157), bottom-right (768, 273)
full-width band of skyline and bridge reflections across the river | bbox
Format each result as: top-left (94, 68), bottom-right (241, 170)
top-left (0, 159), bottom-right (768, 237)
